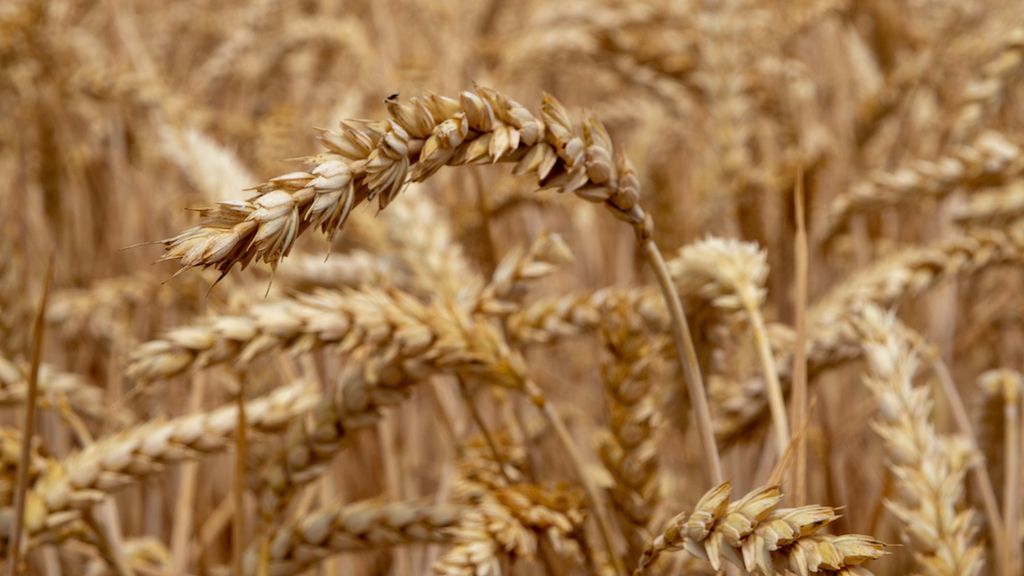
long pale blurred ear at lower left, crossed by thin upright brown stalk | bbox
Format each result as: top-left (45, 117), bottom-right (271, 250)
top-left (18, 384), bottom-right (316, 536)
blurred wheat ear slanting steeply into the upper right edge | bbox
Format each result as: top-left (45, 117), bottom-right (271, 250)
top-left (948, 25), bottom-right (1024, 145)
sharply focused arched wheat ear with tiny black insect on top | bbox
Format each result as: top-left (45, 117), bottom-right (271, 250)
top-left (163, 87), bottom-right (649, 274)
